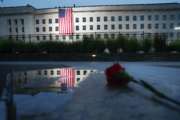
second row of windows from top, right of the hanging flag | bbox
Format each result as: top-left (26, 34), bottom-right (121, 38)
top-left (76, 23), bottom-right (180, 31)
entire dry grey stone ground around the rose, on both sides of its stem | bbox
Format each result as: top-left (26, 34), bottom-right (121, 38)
top-left (1, 62), bottom-right (180, 120)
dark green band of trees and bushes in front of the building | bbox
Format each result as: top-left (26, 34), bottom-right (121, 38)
top-left (0, 35), bottom-right (180, 54)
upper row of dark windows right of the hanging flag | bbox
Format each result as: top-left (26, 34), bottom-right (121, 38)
top-left (75, 14), bottom-right (180, 23)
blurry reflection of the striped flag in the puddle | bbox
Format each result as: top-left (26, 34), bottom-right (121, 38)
top-left (57, 68), bottom-right (75, 88)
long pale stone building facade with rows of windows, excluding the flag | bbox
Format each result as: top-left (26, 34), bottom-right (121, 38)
top-left (0, 3), bottom-right (180, 42)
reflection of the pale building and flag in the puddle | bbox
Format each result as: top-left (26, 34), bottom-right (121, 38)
top-left (13, 67), bottom-right (96, 88)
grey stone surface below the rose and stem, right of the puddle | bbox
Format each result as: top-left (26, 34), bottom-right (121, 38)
top-left (57, 73), bottom-right (180, 120)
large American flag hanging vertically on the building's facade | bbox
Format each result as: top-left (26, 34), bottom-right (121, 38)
top-left (59, 8), bottom-right (73, 35)
